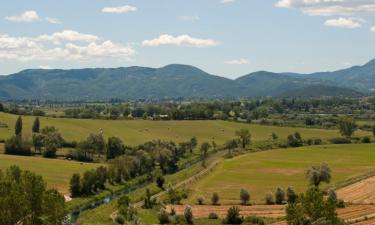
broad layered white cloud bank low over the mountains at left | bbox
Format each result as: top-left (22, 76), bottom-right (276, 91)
top-left (0, 31), bottom-right (135, 61)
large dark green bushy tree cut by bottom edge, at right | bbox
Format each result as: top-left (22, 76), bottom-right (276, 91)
top-left (286, 186), bottom-right (344, 225)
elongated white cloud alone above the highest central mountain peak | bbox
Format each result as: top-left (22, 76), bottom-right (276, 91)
top-left (142, 34), bottom-right (219, 48)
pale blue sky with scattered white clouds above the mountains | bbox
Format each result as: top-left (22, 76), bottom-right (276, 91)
top-left (0, 0), bottom-right (375, 78)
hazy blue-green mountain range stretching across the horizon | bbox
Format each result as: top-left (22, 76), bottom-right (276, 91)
top-left (0, 60), bottom-right (375, 101)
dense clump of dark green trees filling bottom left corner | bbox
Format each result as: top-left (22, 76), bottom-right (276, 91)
top-left (0, 166), bottom-right (65, 225)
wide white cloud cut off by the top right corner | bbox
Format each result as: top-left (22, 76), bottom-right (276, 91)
top-left (276, 0), bottom-right (375, 16)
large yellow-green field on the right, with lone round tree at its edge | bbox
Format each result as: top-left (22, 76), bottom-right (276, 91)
top-left (189, 144), bottom-right (375, 204)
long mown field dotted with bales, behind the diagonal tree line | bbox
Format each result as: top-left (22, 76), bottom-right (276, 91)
top-left (0, 113), bottom-right (370, 145)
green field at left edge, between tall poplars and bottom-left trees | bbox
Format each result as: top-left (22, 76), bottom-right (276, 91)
top-left (0, 154), bottom-right (98, 194)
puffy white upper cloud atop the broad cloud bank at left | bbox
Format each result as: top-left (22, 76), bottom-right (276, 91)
top-left (37, 30), bottom-right (101, 44)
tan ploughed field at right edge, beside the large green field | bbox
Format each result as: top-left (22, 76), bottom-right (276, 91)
top-left (337, 176), bottom-right (375, 204)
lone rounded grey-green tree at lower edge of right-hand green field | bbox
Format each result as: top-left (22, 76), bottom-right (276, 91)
top-left (306, 163), bottom-right (331, 187)
